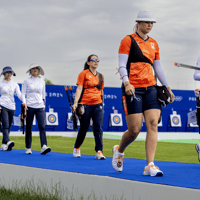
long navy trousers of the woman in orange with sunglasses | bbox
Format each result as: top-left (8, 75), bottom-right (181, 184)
top-left (74, 103), bottom-right (104, 152)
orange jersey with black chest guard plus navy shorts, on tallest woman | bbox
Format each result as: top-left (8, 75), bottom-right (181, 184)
top-left (118, 33), bottom-right (161, 115)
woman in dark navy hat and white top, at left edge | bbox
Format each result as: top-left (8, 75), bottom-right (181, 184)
top-left (0, 66), bottom-right (21, 151)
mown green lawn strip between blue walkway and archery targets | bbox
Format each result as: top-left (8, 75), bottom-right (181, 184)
top-left (4, 136), bottom-right (199, 163)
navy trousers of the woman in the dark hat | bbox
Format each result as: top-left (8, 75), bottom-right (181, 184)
top-left (1, 106), bottom-right (15, 144)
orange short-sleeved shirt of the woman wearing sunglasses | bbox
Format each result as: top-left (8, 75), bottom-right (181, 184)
top-left (76, 69), bottom-right (104, 105)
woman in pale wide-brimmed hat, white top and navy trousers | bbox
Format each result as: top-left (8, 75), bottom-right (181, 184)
top-left (22, 63), bottom-right (51, 155)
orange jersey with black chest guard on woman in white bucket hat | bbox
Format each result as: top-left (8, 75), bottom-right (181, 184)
top-left (118, 33), bottom-right (160, 88)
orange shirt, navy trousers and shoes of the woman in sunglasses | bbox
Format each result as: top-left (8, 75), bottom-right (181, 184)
top-left (73, 69), bottom-right (105, 159)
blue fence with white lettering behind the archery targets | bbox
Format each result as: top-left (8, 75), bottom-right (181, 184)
top-left (11, 84), bottom-right (198, 132)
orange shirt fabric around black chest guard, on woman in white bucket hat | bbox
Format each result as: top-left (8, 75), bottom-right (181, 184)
top-left (118, 33), bottom-right (160, 88)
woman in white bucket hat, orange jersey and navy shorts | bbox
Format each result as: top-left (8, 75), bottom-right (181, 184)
top-left (112, 11), bottom-right (174, 176)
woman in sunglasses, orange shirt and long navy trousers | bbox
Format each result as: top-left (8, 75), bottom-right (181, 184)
top-left (72, 54), bottom-right (106, 160)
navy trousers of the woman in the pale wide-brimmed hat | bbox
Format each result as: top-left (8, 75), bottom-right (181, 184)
top-left (25, 107), bottom-right (47, 148)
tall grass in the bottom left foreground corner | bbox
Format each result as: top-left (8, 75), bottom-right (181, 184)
top-left (0, 179), bottom-right (125, 200)
